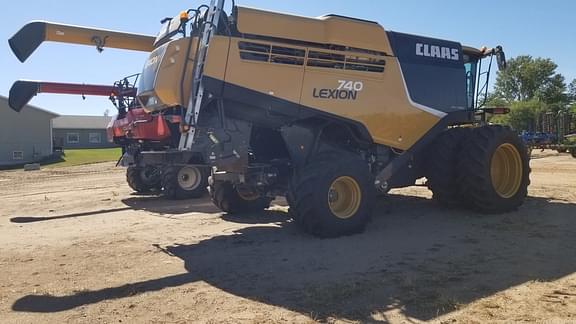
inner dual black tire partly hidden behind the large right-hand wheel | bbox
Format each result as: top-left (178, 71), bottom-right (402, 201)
top-left (426, 127), bottom-right (471, 206)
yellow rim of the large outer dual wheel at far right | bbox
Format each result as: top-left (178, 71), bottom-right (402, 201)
top-left (490, 143), bottom-right (523, 198)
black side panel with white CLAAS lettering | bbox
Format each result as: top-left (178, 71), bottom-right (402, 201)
top-left (388, 32), bottom-right (466, 112)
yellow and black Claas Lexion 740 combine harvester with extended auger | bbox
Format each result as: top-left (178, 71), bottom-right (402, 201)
top-left (11, 0), bottom-right (530, 237)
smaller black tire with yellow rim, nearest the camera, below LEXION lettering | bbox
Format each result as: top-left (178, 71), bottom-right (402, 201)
top-left (287, 155), bottom-right (376, 238)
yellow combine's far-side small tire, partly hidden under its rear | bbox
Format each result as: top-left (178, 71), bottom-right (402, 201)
top-left (209, 181), bottom-right (272, 214)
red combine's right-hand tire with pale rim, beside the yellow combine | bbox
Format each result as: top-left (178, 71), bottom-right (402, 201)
top-left (162, 165), bottom-right (208, 200)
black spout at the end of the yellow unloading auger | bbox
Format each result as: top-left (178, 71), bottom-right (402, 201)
top-left (8, 21), bottom-right (46, 62)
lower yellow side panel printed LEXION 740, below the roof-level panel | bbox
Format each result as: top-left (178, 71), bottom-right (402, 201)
top-left (220, 38), bottom-right (440, 150)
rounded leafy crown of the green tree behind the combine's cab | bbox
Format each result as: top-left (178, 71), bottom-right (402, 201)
top-left (494, 55), bottom-right (568, 105)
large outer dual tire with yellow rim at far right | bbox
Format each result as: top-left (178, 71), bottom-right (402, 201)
top-left (458, 125), bottom-right (530, 213)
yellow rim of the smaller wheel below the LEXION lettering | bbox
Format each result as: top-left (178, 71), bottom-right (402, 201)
top-left (328, 177), bottom-right (362, 219)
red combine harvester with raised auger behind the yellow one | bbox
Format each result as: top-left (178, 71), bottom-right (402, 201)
top-left (9, 75), bottom-right (210, 199)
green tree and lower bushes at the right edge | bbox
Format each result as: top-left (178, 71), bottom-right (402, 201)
top-left (487, 55), bottom-right (576, 131)
